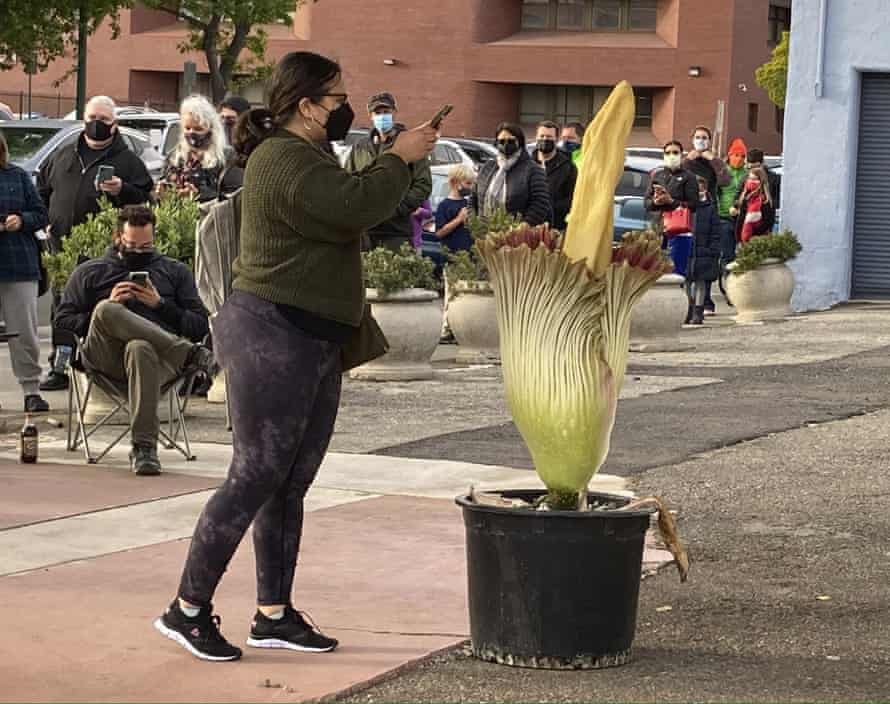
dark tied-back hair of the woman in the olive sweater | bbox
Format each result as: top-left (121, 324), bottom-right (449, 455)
top-left (232, 51), bottom-right (341, 161)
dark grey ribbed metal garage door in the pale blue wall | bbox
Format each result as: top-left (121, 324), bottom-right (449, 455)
top-left (853, 73), bottom-right (890, 298)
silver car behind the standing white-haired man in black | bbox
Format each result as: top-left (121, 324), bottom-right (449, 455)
top-left (0, 120), bottom-right (164, 180)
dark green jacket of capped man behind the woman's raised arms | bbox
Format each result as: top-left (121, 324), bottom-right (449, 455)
top-left (346, 125), bottom-right (433, 242)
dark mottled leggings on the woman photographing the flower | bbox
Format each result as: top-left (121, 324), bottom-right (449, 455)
top-left (179, 291), bottom-right (341, 606)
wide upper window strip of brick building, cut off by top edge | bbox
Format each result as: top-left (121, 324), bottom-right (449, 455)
top-left (522, 0), bottom-right (658, 32)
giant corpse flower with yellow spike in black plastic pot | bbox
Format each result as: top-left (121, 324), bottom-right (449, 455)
top-left (458, 82), bottom-right (688, 669)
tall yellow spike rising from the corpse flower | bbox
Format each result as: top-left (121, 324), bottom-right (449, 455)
top-left (563, 81), bottom-right (636, 276)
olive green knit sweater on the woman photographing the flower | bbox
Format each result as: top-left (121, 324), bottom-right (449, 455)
top-left (233, 129), bottom-right (411, 326)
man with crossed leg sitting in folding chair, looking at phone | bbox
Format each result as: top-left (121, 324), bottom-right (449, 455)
top-left (55, 205), bottom-right (214, 475)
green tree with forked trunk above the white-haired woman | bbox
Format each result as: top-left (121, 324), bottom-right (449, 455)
top-left (142, 0), bottom-right (303, 102)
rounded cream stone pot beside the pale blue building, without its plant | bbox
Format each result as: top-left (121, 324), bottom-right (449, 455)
top-left (726, 259), bottom-right (794, 323)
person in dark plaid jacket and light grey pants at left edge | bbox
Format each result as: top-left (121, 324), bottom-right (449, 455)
top-left (0, 131), bottom-right (49, 413)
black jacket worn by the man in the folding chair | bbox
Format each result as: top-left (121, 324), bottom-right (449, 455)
top-left (53, 247), bottom-right (210, 342)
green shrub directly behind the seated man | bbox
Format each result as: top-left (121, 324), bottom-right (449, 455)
top-left (43, 193), bottom-right (200, 290)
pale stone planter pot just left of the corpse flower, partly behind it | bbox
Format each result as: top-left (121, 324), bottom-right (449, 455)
top-left (447, 281), bottom-right (501, 364)
